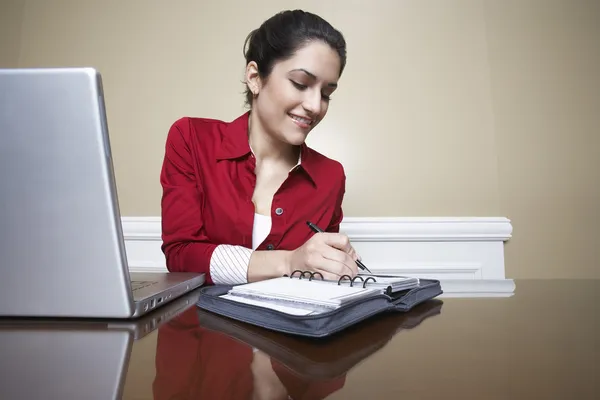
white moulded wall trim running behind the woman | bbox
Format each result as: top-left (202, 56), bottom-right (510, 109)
top-left (122, 217), bottom-right (515, 296)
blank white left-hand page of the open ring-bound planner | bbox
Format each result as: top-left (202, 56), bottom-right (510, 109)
top-left (230, 277), bottom-right (379, 308)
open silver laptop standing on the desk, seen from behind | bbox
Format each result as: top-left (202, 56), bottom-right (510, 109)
top-left (0, 68), bottom-right (205, 318)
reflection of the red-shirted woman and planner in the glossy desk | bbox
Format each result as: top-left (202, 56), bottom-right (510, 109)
top-left (153, 300), bottom-right (443, 400)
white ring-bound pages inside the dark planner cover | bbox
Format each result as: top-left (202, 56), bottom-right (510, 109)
top-left (221, 271), bottom-right (419, 315)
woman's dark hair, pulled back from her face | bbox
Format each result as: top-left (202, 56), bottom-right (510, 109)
top-left (244, 10), bottom-right (346, 105)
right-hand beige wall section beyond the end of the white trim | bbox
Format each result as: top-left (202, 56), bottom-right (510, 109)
top-left (485, 0), bottom-right (600, 278)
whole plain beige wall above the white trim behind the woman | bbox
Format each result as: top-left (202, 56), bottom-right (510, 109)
top-left (0, 0), bottom-right (600, 278)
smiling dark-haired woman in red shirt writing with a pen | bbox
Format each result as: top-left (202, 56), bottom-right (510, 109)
top-left (160, 10), bottom-right (358, 284)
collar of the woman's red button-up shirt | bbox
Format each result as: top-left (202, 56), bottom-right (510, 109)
top-left (217, 111), bottom-right (317, 185)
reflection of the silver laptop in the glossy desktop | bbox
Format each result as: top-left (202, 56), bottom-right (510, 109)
top-left (0, 289), bottom-right (199, 400)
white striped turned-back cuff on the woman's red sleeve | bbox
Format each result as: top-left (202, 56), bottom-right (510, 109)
top-left (210, 244), bottom-right (252, 285)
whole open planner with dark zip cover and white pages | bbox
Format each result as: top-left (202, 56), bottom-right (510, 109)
top-left (197, 271), bottom-right (443, 338)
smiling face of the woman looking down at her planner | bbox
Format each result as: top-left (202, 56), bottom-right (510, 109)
top-left (248, 41), bottom-right (340, 145)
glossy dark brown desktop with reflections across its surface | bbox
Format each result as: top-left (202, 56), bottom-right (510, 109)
top-left (0, 280), bottom-right (600, 400)
